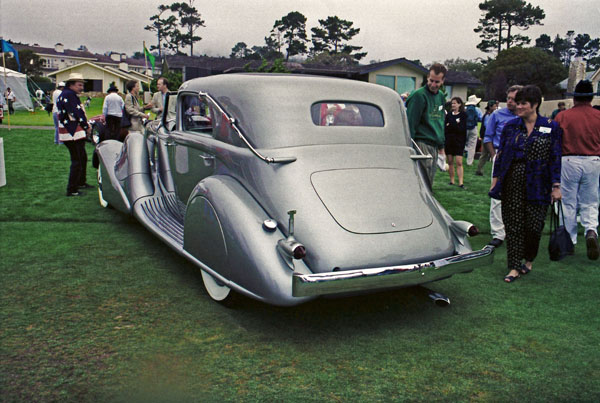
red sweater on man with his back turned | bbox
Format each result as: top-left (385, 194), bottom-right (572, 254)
top-left (555, 104), bottom-right (600, 156)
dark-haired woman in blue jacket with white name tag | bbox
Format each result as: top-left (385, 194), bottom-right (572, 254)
top-left (489, 85), bottom-right (562, 283)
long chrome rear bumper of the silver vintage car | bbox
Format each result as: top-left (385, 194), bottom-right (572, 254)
top-left (292, 246), bottom-right (494, 297)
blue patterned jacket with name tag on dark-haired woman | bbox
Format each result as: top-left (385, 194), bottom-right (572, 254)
top-left (489, 116), bottom-right (562, 204)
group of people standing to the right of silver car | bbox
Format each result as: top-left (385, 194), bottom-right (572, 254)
top-left (406, 63), bottom-right (600, 283)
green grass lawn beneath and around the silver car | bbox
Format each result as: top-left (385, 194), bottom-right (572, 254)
top-left (0, 129), bottom-right (600, 402)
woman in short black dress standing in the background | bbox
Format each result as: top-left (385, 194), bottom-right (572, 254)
top-left (444, 97), bottom-right (467, 189)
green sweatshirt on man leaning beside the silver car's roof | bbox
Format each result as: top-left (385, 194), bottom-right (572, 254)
top-left (406, 87), bottom-right (446, 148)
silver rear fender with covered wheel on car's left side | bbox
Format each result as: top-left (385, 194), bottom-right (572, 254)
top-left (184, 176), bottom-right (311, 305)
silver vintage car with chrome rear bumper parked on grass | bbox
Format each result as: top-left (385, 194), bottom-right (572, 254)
top-left (97, 74), bottom-right (494, 306)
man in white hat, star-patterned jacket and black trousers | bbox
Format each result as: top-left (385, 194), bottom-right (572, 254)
top-left (56, 73), bottom-right (92, 196)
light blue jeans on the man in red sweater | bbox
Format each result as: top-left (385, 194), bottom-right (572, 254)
top-left (560, 155), bottom-right (600, 245)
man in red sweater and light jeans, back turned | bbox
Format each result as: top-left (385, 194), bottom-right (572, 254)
top-left (556, 80), bottom-right (600, 260)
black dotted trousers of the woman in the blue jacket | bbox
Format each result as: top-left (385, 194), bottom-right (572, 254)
top-left (502, 162), bottom-right (548, 270)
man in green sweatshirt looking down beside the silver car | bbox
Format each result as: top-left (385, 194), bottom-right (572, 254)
top-left (406, 63), bottom-right (448, 186)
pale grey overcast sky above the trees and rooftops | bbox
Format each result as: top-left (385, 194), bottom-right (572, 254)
top-left (0, 0), bottom-right (600, 63)
